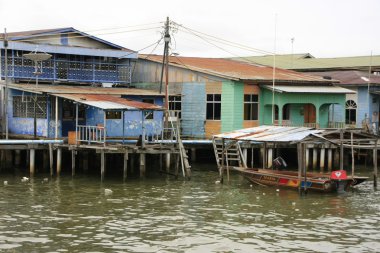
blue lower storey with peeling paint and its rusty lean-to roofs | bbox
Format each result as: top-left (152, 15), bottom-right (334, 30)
top-left (8, 84), bottom-right (163, 143)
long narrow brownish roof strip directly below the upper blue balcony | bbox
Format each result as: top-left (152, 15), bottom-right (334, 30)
top-left (8, 84), bottom-right (164, 96)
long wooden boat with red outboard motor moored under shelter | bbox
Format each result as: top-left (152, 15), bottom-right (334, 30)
top-left (233, 167), bottom-right (368, 192)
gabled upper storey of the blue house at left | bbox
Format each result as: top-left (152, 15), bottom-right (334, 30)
top-left (0, 27), bottom-right (137, 85)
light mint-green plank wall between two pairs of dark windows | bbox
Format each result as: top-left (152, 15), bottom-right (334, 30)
top-left (221, 81), bottom-right (244, 132)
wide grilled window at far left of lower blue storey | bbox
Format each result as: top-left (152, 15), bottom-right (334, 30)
top-left (13, 96), bottom-right (46, 119)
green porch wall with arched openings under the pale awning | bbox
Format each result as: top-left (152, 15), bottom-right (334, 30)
top-left (260, 87), bottom-right (346, 128)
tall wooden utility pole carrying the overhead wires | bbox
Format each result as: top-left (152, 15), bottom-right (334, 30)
top-left (160, 17), bottom-right (170, 127)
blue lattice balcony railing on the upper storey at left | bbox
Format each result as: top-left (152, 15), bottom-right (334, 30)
top-left (1, 56), bottom-right (131, 84)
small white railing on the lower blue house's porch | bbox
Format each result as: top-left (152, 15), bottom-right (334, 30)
top-left (76, 125), bottom-right (106, 144)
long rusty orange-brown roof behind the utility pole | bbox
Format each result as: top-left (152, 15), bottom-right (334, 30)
top-left (142, 55), bottom-right (332, 83)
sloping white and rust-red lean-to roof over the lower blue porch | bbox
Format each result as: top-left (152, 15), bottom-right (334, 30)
top-left (56, 94), bottom-right (164, 111)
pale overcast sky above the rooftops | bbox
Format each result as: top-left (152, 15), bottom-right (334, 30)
top-left (0, 0), bottom-right (380, 57)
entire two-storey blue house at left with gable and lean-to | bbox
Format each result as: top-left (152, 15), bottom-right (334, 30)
top-left (0, 28), bottom-right (163, 142)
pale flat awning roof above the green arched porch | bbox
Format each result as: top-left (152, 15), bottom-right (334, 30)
top-left (263, 85), bottom-right (356, 94)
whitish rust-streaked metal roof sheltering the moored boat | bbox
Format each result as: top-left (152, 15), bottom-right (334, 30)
top-left (214, 126), bottom-right (324, 142)
